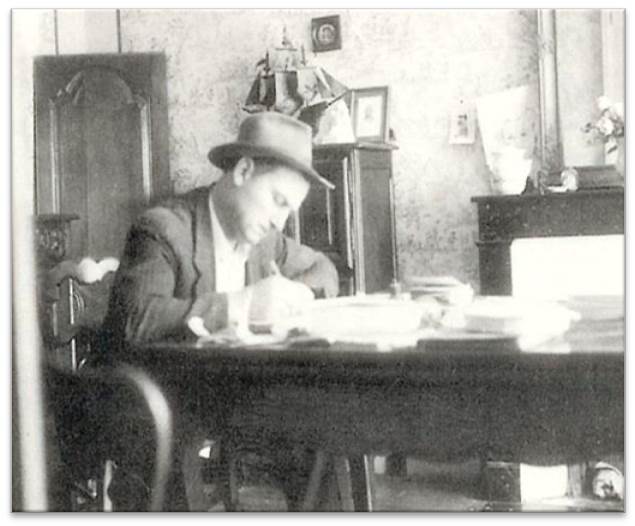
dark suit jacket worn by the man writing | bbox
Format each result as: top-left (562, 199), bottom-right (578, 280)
top-left (104, 188), bottom-right (338, 350)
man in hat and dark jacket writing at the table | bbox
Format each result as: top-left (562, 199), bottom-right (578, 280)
top-left (104, 112), bottom-right (338, 506)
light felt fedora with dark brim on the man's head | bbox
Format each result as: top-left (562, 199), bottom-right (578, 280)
top-left (207, 111), bottom-right (335, 190)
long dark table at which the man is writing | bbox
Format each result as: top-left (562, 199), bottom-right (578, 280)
top-left (129, 300), bottom-right (624, 507)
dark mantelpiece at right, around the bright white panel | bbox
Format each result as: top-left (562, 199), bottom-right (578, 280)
top-left (472, 188), bottom-right (624, 295)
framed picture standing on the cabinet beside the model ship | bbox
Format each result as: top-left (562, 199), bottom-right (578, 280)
top-left (350, 86), bottom-right (388, 142)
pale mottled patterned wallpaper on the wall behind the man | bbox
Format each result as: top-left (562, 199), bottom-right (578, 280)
top-left (121, 10), bottom-right (538, 290)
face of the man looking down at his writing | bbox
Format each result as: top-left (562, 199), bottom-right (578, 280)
top-left (234, 162), bottom-right (310, 245)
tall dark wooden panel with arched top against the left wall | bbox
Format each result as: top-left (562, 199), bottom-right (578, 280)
top-left (34, 54), bottom-right (169, 258)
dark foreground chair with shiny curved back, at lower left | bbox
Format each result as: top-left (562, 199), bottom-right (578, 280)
top-left (47, 366), bottom-right (173, 511)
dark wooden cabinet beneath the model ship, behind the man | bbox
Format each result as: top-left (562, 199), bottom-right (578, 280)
top-left (296, 143), bottom-right (396, 295)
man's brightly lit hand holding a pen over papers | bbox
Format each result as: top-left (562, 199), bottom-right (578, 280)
top-left (249, 274), bottom-right (314, 322)
